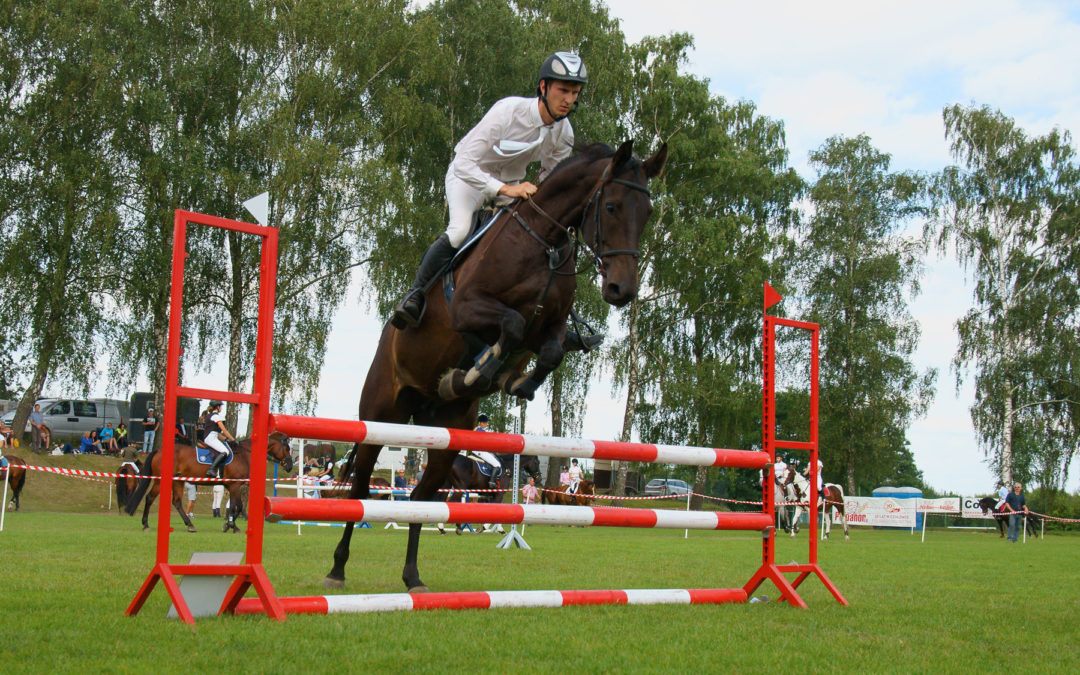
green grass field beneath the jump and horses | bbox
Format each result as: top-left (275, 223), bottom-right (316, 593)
top-left (0, 503), bottom-right (1080, 673)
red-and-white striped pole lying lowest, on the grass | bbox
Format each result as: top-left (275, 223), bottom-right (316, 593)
top-left (235, 589), bottom-right (746, 615)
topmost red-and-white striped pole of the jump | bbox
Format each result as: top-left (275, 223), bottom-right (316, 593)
top-left (270, 415), bottom-right (769, 469)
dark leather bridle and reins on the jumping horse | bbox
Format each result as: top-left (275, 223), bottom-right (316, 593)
top-left (510, 156), bottom-right (652, 275)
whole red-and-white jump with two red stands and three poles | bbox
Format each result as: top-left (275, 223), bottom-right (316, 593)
top-left (125, 210), bottom-right (848, 624)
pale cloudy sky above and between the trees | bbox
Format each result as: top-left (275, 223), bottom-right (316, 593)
top-left (113, 0), bottom-right (1080, 495)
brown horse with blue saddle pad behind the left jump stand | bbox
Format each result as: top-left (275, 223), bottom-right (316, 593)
top-left (125, 432), bottom-right (293, 532)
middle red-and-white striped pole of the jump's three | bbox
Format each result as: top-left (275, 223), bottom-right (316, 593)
top-left (264, 497), bottom-right (772, 530)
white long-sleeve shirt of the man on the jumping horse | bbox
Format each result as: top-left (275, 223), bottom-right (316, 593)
top-left (450, 96), bottom-right (573, 200)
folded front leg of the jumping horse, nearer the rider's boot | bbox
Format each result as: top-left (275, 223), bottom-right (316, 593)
top-left (438, 299), bottom-right (526, 401)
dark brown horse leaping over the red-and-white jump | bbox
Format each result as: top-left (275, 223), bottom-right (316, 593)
top-left (324, 141), bottom-right (667, 591)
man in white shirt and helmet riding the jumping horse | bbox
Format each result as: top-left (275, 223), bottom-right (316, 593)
top-left (391, 52), bottom-right (604, 350)
